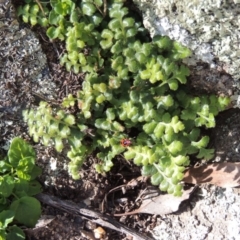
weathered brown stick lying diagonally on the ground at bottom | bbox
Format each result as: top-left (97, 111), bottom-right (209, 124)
top-left (36, 193), bottom-right (152, 240)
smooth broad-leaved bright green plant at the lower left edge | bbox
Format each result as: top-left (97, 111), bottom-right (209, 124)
top-left (0, 138), bottom-right (41, 240)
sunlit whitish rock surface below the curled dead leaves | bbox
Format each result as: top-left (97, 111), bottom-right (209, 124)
top-left (152, 185), bottom-right (240, 240)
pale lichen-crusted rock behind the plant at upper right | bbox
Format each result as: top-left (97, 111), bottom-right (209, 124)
top-left (134, 0), bottom-right (240, 80)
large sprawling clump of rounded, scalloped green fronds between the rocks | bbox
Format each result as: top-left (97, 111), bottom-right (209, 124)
top-left (20, 0), bottom-right (229, 195)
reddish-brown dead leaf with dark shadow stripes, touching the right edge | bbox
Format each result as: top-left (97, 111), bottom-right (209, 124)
top-left (182, 162), bottom-right (240, 187)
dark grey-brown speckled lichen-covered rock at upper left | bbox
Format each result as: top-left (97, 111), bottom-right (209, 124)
top-left (0, 0), bottom-right (56, 106)
